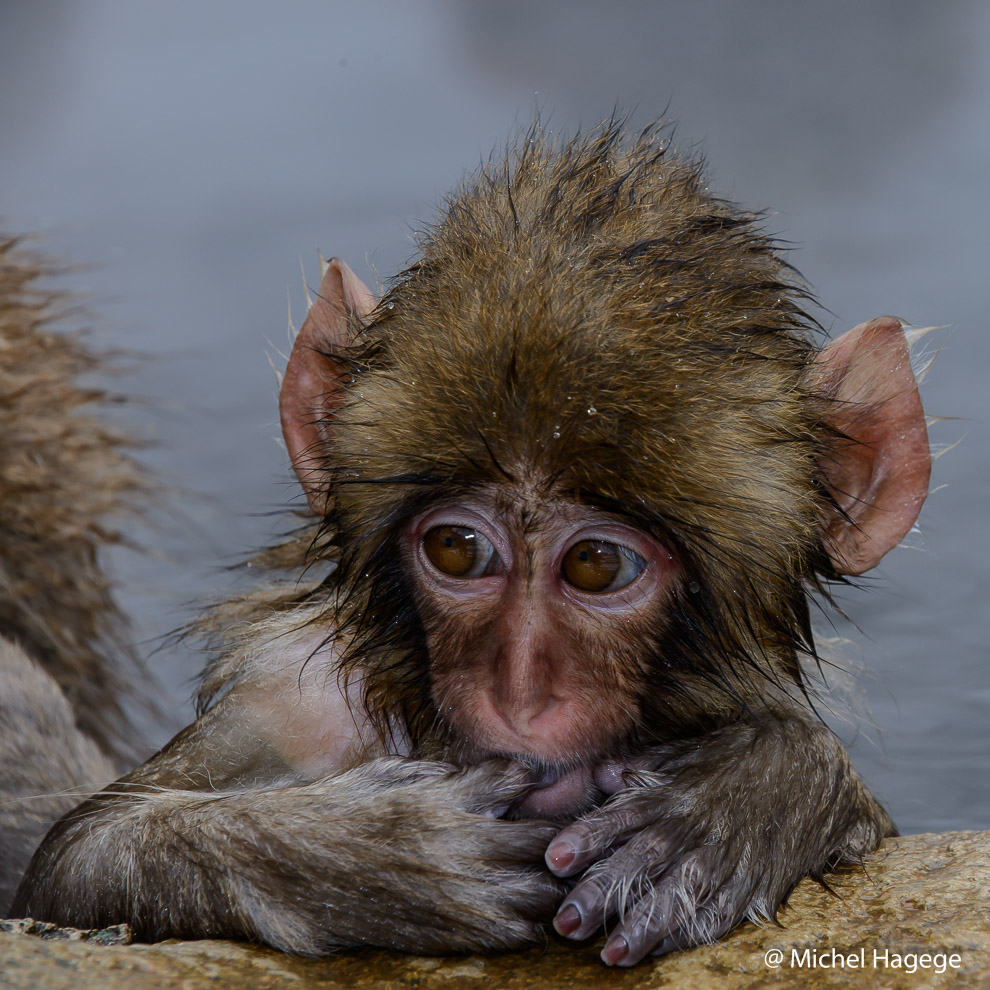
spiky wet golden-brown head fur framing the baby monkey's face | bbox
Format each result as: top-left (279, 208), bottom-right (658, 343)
top-left (314, 121), bottom-right (831, 737)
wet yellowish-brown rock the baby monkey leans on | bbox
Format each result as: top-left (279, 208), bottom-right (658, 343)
top-left (0, 831), bottom-right (990, 990)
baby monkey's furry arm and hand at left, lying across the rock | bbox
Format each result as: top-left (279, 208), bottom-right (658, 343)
top-left (13, 688), bottom-right (559, 955)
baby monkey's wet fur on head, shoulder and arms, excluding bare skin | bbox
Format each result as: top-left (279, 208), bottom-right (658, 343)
top-left (11, 123), bottom-right (920, 954)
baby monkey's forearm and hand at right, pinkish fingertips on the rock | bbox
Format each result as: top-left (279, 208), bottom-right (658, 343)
top-left (547, 710), bottom-right (895, 966)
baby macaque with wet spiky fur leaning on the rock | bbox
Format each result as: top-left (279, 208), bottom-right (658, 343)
top-left (14, 124), bottom-right (930, 965)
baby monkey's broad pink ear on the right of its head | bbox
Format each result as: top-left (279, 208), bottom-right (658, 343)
top-left (813, 316), bottom-right (931, 574)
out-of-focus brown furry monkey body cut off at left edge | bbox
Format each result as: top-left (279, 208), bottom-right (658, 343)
top-left (0, 237), bottom-right (144, 914)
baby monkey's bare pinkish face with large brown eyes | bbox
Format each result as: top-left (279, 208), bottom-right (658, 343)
top-left (404, 490), bottom-right (679, 801)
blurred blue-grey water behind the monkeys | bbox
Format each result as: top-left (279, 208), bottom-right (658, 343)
top-left (0, 0), bottom-right (990, 831)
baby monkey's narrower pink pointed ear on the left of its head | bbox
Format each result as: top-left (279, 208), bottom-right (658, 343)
top-left (278, 258), bottom-right (378, 515)
